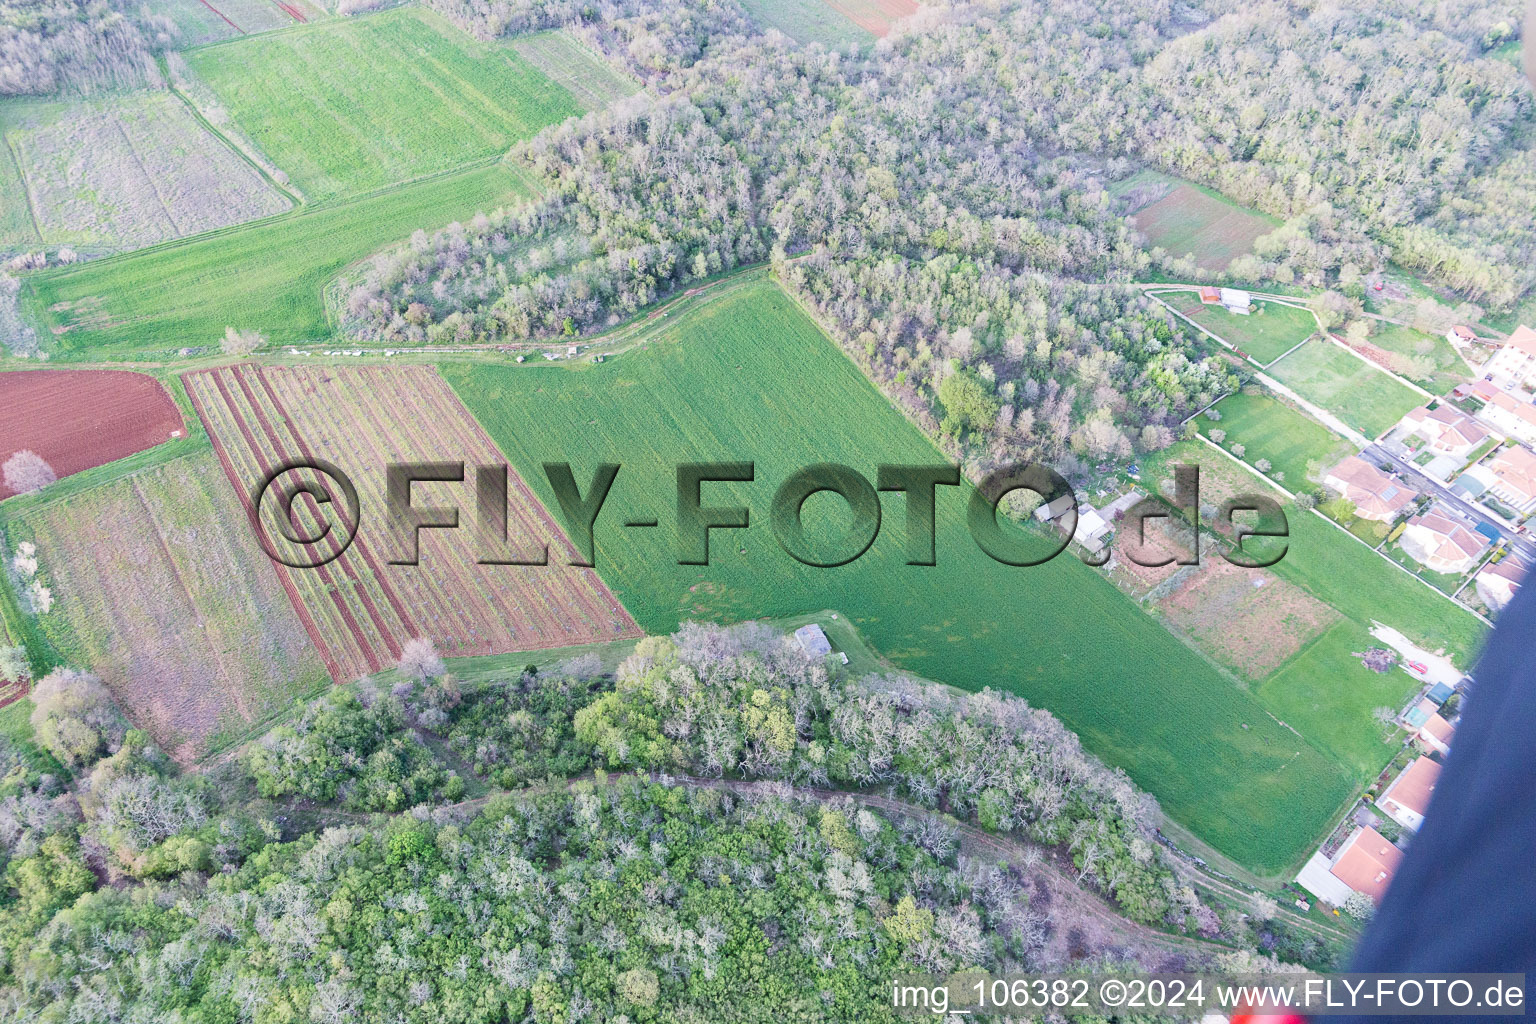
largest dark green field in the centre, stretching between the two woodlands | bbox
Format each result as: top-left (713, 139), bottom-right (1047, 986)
top-left (444, 282), bottom-right (1353, 869)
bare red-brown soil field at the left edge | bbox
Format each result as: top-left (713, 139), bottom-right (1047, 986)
top-left (0, 370), bottom-right (186, 499)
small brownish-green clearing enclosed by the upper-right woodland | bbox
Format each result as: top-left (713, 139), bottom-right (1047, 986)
top-left (1115, 170), bottom-right (1279, 270)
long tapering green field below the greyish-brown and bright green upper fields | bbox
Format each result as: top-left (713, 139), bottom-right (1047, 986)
top-left (22, 164), bottom-right (528, 359)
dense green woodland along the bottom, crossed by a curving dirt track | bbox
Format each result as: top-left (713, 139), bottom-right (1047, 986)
top-left (0, 623), bottom-right (1332, 1024)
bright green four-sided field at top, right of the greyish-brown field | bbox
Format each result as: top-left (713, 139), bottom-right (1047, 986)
top-left (187, 8), bottom-right (582, 200)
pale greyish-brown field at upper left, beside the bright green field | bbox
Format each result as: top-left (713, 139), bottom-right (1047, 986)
top-left (0, 91), bottom-right (289, 247)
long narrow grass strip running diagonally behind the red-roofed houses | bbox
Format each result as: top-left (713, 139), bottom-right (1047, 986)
top-left (1141, 441), bottom-right (1485, 666)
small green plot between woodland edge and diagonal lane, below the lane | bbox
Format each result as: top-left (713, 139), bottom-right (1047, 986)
top-left (1195, 395), bottom-right (1355, 491)
